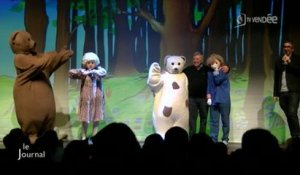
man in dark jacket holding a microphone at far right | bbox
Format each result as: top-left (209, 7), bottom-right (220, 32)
top-left (273, 40), bottom-right (300, 137)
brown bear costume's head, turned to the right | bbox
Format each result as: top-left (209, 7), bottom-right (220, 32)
top-left (9, 31), bottom-right (36, 54)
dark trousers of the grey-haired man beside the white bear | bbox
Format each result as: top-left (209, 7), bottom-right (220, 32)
top-left (189, 98), bottom-right (208, 136)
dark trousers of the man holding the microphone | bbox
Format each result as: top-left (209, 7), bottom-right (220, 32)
top-left (279, 92), bottom-right (300, 137)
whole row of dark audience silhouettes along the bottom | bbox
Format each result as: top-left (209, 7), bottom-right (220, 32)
top-left (0, 122), bottom-right (300, 175)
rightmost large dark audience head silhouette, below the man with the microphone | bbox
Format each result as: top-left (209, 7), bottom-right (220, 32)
top-left (231, 128), bottom-right (285, 174)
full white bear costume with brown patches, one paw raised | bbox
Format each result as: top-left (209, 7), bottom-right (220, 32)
top-left (147, 55), bottom-right (189, 138)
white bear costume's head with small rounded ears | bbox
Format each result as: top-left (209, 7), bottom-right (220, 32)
top-left (164, 55), bottom-right (186, 74)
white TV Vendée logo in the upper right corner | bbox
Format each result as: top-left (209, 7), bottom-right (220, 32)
top-left (235, 13), bottom-right (278, 28)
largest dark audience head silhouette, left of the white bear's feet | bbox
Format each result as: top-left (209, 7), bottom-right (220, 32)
top-left (91, 122), bottom-right (141, 173)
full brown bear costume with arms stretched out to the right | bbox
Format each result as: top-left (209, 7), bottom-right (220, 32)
top-left (9, 31), bottom-right (73, 143)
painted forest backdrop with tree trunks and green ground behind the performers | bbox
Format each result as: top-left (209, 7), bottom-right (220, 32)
top-left (0, 0), bottom-right (300, 142)
